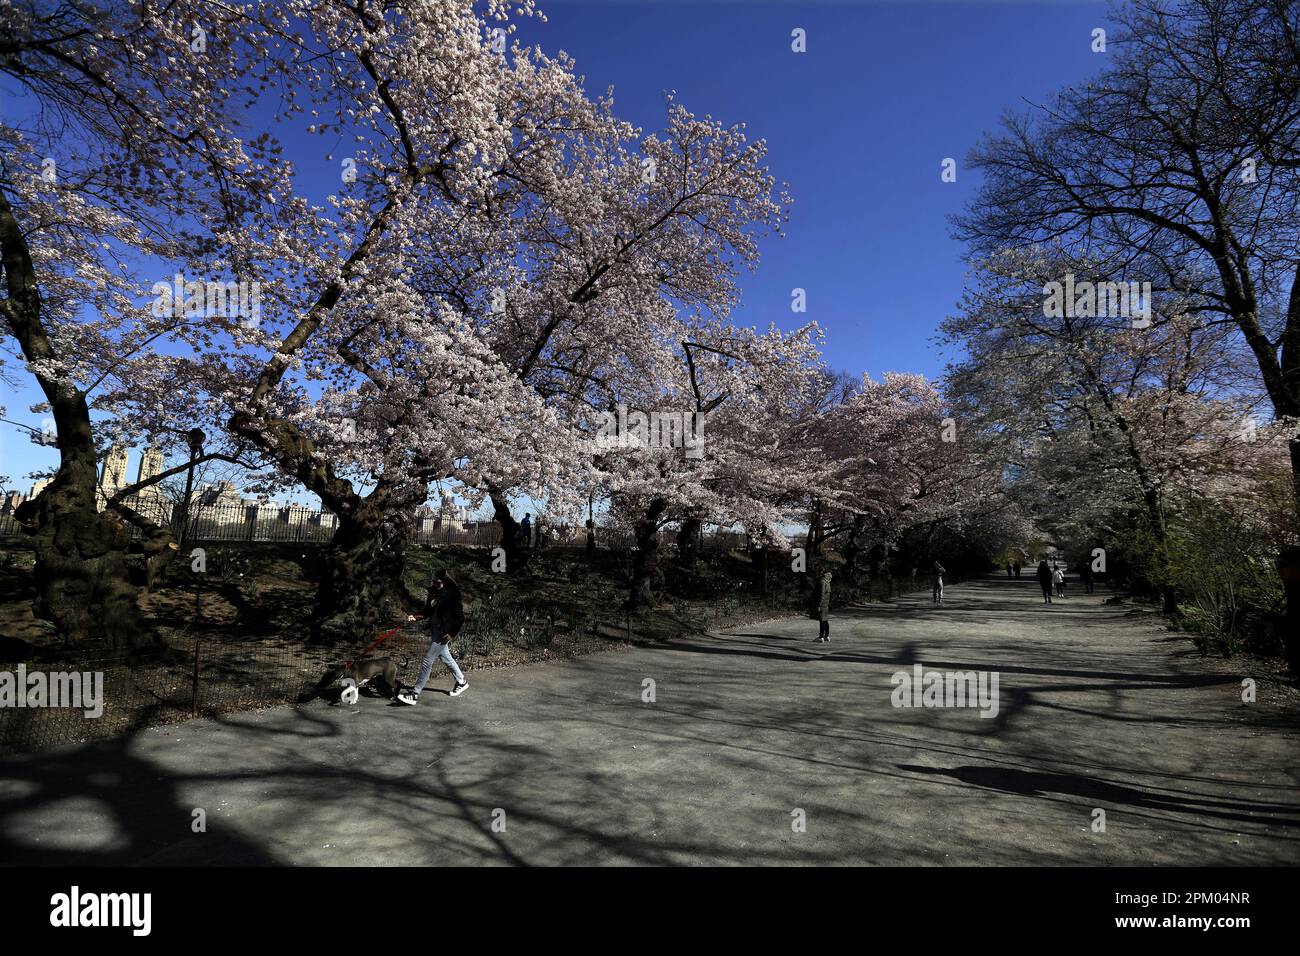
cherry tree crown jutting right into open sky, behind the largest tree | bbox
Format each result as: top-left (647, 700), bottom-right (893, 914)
top-left (449, 98), bottom-right (784, 574)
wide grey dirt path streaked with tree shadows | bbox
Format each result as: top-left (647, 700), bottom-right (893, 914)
top-left (0, 579), bottom-right (1300, 865)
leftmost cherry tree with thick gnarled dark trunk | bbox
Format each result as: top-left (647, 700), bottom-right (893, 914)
top-left (0, 0), bottom-right (286, 648)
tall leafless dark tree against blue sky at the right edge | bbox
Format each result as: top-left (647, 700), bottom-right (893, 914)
top-left (956, 0), bottom-right (1300, 674)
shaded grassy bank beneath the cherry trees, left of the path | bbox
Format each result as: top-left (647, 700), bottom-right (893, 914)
top-left (0, 546), bottom-right (811, 749)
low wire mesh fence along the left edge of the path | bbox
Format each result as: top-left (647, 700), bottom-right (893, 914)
top-left (0, 567), bottom-right (928, 753)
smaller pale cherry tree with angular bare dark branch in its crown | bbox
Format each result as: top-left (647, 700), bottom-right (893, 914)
top-left (595, 320), bottom-right (820, 610)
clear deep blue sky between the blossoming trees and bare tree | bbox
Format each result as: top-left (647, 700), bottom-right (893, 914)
top-left (0, 0), bottom-right (1110, 492)
